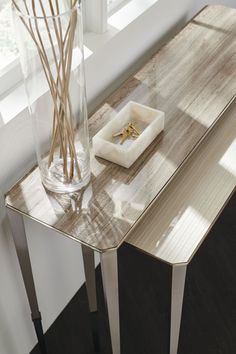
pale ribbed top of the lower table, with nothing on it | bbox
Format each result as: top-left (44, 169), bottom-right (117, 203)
top-left (126, 99), bottom-right (236, 264)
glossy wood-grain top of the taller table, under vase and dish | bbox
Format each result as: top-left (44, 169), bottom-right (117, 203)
top-left (6, 6), bottom-right (236, 252)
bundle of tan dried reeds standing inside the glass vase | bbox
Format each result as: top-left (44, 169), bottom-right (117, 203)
top-left (12, 0), bottom-right (81, 183)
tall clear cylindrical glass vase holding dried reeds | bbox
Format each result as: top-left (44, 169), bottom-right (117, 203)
top-left (12, 0), bottom-right (90, 193)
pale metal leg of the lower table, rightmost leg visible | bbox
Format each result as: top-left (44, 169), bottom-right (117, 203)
top-left (170, 264), bottom-right (187, 354)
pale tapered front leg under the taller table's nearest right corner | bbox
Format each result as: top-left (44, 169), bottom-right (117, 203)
top-left (100, 251), bottom-right (120, 354)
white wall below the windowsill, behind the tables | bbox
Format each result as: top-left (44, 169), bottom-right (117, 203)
top-left (0, 0), bottom-right (235, 354)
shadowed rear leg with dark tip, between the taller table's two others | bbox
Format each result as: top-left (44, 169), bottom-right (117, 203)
top-left (82, 245), bottom-right (100, 353)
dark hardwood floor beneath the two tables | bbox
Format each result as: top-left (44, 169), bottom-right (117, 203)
top-left (31, 193), bottom-right (236, 354)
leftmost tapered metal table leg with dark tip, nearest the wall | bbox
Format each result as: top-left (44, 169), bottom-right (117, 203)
top-left (7, 208), bottom-right (47, 354)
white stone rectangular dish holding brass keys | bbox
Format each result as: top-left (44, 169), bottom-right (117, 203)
top-left (93, 101), bottom-right (165, 168)
